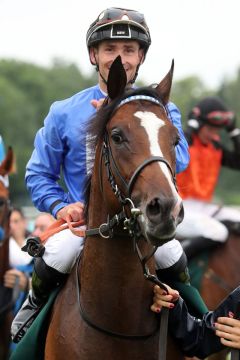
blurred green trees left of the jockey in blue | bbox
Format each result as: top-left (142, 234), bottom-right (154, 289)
top-left (0, 59), bottom-right (96, 205)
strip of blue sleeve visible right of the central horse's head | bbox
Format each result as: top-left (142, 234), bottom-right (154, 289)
top-left (167, 102), bottom-right (189, 173)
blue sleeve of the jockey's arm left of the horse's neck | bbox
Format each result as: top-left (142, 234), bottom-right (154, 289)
top-left (25, 104), bottom-right (68, 216)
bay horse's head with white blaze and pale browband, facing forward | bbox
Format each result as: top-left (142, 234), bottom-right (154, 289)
top-left (88, 57), bottom-right (183, 245)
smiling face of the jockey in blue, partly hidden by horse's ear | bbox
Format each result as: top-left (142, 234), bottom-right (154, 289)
top-left (90, 40), bottom-right (144, 92)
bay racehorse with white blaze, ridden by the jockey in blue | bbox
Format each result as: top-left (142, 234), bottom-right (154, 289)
top-left (45, 57), bottom-right (183, 360)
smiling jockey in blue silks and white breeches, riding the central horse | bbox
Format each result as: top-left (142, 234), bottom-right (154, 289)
top-left (12, 8), bottom-right (192, 341)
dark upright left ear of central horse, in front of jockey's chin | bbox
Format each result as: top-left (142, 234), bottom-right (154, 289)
top-left (107, 55), bottom-right (127, 100)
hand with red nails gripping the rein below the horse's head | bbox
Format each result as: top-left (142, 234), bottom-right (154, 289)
top-left (151, 284), bottom-right (179, 313)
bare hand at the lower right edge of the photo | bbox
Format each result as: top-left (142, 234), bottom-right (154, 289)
top-left (214, 313), bottom-right (240, 349)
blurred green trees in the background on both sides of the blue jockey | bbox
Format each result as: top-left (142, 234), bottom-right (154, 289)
top-left (0, 59), bottom-right (240, 205)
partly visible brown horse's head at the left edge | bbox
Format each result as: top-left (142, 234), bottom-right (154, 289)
top-left (0, 148), bottom-right (14, 243)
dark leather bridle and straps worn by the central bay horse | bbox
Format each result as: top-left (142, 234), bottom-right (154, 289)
top-left (77, 95), bottom-right (176, 359)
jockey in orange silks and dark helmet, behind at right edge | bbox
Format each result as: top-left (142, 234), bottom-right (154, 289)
top-left (177, 97), bottom-right (240, 258)
